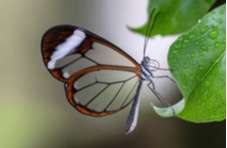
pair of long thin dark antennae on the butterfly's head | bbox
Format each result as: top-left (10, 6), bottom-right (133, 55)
top-left (143, 8), bottom-right (160, 58)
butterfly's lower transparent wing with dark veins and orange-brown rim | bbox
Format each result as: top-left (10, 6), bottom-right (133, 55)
top-left (65, 67), bottom-right (139, 116)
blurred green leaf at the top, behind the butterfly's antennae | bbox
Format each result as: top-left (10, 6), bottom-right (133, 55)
top-left (129, 0), bottom-right (215, 36)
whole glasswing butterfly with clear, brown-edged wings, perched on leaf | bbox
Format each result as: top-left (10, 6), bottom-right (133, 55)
top-left (41, 10), bottom-right (175, 133)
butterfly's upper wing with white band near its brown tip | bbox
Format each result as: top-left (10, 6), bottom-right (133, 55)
top-left (41, 26), bottom-right (139, 81)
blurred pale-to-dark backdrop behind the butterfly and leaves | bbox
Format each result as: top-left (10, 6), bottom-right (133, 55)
top-left (0, 0), bottom-right (226, 148)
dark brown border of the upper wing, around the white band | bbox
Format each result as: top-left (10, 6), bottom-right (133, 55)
top-left (41, 25), bottom-right (140, 82)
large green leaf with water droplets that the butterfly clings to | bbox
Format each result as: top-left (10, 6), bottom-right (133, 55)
top-left (168, 5), bottom-right (226, 122)
